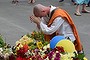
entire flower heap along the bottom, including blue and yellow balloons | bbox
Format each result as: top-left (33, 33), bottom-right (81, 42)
top-left (0, 31), bottom-right (87, 60)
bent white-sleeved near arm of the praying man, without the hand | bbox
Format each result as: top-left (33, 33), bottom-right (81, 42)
top-left (40, 17), bottom-right (64, 35)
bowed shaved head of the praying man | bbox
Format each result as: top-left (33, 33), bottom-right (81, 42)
top-left (33, 4), bottom-right (48, 17)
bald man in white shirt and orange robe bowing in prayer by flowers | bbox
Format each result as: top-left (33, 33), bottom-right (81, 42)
top-left (30, 4), bottom-right (82, 52)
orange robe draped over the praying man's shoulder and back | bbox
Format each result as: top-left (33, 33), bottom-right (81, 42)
top-left (44, 8), bottom-right (82, 51)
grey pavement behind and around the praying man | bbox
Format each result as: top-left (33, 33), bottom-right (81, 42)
top-left (0, 0), bottom-right (90, 60)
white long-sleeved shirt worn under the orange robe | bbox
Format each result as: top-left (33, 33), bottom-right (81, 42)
top-left (40, 6), bottom-right (75, 41)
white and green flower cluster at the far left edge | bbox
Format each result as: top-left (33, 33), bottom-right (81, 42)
top-left (0, 35), bottom-right (14, 60)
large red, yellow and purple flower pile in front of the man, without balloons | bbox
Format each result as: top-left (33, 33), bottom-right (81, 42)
top-left (13, 31), bottom-right (87, 60)
